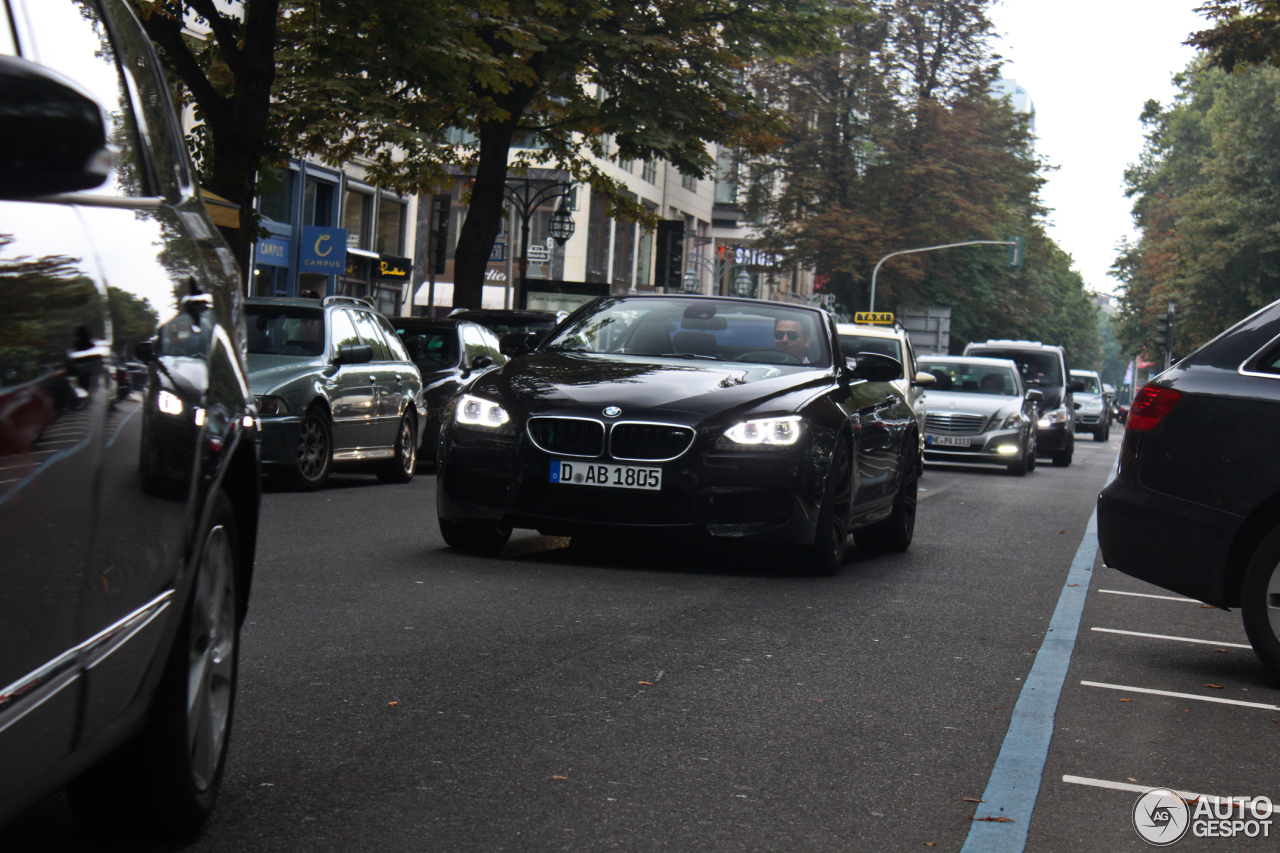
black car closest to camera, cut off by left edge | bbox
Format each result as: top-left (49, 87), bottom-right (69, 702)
top-left (0, 0), bottom-right (260, 829)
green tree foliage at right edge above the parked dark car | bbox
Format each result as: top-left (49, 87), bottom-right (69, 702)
top-left (1114, 59), bottom-right (1280, 361)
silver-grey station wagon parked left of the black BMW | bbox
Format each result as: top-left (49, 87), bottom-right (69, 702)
top-left (244, 296), bottom-right (426, 489)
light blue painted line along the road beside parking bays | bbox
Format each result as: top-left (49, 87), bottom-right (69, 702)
top-left (960, 466), bottom-right (1115, 853)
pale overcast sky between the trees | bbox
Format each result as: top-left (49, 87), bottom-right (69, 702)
top-left (991, 0), bottom-right (1206, 292)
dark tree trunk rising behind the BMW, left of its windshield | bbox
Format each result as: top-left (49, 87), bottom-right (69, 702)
top-left (453, 116), bottom-right (522, 309)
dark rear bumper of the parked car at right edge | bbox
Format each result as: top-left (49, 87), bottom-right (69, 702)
top-left (1098, 478), bottom-right (1244, 607)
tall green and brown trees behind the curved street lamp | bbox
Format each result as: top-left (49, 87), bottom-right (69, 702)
top-left (740, 0), bottom-right (1098, 362)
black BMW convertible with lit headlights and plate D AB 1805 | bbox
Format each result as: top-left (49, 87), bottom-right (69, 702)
top-left (436, 296), bottom-right (920, 574)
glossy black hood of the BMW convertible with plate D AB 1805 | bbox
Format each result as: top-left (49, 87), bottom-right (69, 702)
top-left (475, 352), bottom-right (833, 423)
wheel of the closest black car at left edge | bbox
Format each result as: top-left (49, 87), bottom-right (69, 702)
top-left (68, 492), bottom-right (242, 839)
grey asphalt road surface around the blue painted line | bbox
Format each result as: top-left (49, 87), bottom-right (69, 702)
top-left (12, 430), bottom-right (1280, 853)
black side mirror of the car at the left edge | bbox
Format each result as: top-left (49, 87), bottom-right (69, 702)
top-left (0, 56), bottom-right (114, 199)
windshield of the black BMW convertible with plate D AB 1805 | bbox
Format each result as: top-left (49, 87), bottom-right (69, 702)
top-left (544, 297), bottom-right (831, 368)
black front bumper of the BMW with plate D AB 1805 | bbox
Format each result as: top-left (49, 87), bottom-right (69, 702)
top-left (436, 425), bottom-right (827, 544)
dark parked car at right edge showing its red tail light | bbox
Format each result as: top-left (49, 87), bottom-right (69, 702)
top-left (1098, 302), bottom-right (1280, 678)
